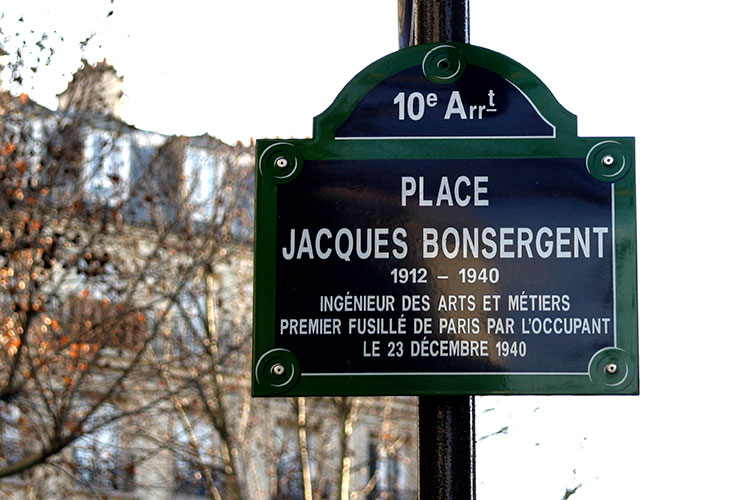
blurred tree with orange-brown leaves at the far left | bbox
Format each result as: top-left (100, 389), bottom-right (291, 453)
top-left (0, 19), bottom-right (256, 484)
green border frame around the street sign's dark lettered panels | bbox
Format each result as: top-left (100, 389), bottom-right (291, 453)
top-left (253, 43), bottom-right (639, 396)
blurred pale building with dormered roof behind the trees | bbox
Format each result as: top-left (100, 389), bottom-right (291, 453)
top-left (0, 61), bottom-right (417, 500)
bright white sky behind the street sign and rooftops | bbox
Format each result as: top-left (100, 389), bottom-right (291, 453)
top-left (1, 0), bottom-right (750, 500)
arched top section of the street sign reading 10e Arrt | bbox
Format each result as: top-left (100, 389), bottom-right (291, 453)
top-left (314, 43), bottom-right (577, 140)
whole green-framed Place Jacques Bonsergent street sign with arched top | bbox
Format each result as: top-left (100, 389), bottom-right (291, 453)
top-left (253, 43), bottom-right (638, 396)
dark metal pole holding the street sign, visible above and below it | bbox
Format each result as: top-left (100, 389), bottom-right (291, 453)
top-left (399, 0), bottom-right (476, 500)
